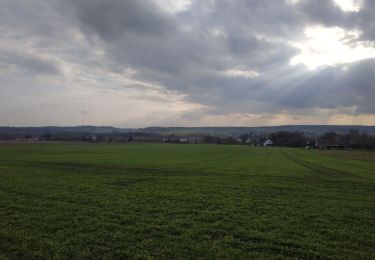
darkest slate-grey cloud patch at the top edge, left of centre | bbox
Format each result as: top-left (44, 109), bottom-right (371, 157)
top-left (71, 0), bottom-right (173, 39)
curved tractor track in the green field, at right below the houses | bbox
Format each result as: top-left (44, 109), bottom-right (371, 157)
top-left (281, 150), bottom-right (362, 179)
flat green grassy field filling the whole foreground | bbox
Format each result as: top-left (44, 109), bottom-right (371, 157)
top-left (0, 144), bottom-right (375, 259)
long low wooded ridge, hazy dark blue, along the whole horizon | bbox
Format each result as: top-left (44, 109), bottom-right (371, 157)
top-left (0, 125), bottom-right (375, 136)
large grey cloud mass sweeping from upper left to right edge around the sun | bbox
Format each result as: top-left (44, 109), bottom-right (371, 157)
top-left (55, 0), bottom-right (375, 116)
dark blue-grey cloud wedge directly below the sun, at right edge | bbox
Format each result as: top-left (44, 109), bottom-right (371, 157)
top-left (275, 59), bottom-right (375, 113)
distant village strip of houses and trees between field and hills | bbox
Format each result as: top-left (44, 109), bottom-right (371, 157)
top-left (0, 129), bottom-right (375, 150)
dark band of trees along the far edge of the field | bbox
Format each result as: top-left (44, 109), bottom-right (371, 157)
top-left (0, 129), bottom-right (375, 149)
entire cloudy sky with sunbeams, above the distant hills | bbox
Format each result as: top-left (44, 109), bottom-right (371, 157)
top-left (0, 0), bottom-right (375, 127)
